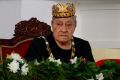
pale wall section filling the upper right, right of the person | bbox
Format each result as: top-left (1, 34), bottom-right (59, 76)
top-left (79, 0), bottom-right (120, 48)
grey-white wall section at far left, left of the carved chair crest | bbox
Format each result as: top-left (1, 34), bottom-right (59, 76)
top-left (0, 0), bottom-right (21, 38)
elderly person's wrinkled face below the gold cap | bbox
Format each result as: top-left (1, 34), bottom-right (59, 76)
top-left (52, 17), bottom-right (76, 43)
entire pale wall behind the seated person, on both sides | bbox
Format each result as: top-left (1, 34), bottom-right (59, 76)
top-left (0, 0), bottom-right (120, 48)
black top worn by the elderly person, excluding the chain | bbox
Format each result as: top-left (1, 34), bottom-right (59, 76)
top-left (25, 35), bottom-right (94, 62)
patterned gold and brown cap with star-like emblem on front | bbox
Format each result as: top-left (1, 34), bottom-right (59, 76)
top-left (52, 3), bottom-right (75, 18)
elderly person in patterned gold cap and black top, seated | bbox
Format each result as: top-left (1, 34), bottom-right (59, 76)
top-left (25, 3), bottom-right (94, 62)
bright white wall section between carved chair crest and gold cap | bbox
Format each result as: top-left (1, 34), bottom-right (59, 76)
top-left (21, 0), bottom-right (55, 25)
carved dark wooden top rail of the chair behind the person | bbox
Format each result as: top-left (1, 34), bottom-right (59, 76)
top-left (0, 17), bottom-right (52, 46)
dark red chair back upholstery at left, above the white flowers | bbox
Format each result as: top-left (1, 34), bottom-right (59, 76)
top-left (2, 40), bottom-right (32, 58)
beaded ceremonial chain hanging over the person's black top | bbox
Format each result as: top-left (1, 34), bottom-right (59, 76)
top-left (41, 36), bottom-right (75, 59)
